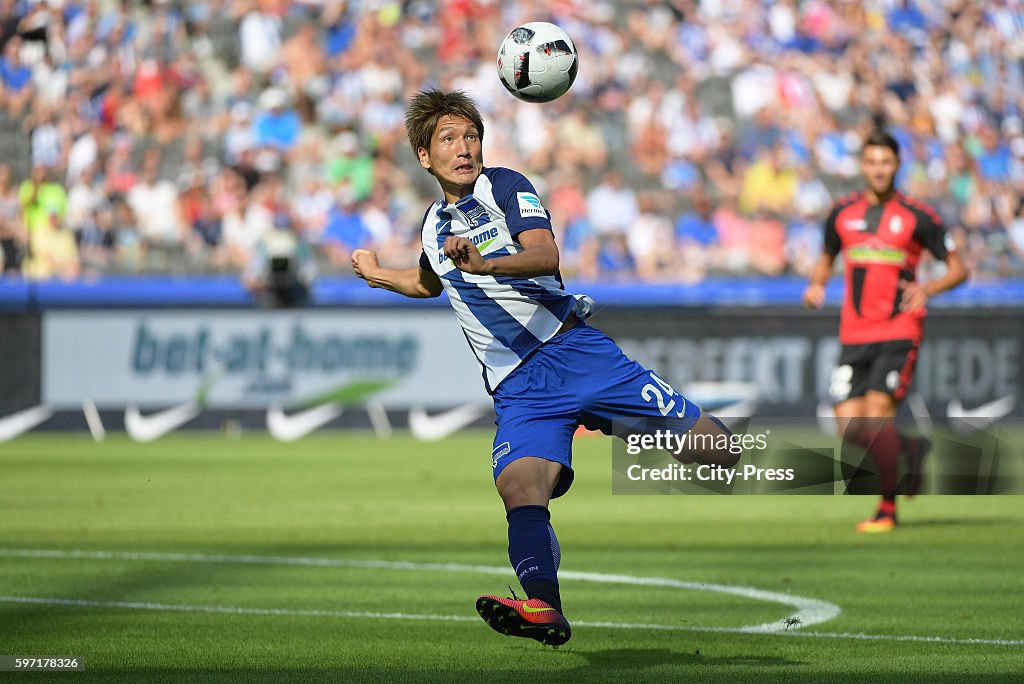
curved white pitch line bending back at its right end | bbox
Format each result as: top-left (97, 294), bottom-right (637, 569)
top-left (0, 549), bottom-right (841, 633)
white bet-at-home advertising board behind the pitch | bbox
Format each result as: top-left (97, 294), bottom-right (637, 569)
top-left (42, 310), bottom-right (487, 409)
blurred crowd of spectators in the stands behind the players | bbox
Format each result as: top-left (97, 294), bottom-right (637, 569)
top-left (0, 0), bottom-right (1024, 290)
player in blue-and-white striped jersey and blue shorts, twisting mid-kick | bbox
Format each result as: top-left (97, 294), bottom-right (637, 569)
top-left (352, 90), bottom-right (737, 645)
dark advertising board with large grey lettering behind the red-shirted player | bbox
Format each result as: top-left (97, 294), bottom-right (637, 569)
top-left (594, 308), bottom-right (1024, 417)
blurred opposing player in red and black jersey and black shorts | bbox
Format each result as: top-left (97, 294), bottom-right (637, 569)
top-left (804, 131), bottom-right (968, 532)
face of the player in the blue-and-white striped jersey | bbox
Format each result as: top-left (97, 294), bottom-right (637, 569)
top-left (419, 115), bottom-right (483, 201)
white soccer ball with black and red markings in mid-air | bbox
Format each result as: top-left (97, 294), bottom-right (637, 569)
top-left (498, 22), bottom-right (580, 102)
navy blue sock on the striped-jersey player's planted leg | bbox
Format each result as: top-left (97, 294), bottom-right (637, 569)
top-left (507, 506), bottom-right (562, 612)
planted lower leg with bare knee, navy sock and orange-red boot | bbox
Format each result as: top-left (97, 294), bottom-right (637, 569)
top-left (476, 458), bottom-right (571, 646)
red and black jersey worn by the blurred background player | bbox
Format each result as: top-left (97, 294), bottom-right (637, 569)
top-left (824, 193), bottom-right (953, 344)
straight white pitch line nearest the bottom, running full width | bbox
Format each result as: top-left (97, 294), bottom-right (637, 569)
top-left (0, 596), bottom-right (1024, 646)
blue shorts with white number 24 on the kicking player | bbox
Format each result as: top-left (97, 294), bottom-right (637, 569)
top-left (490, 324), bottom-right (700, 499)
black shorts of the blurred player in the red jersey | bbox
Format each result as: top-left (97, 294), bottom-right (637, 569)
top-left (828, 340), bottom-right (920, 403)
